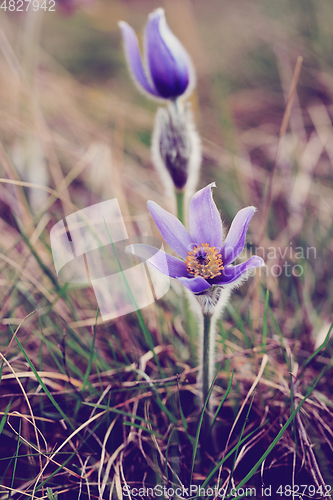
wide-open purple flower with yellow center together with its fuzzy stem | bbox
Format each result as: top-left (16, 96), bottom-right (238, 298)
top-left (127, 183), bottom-right (264, 422)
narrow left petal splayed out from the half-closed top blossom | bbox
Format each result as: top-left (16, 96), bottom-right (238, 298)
top-left (119, 21), bottom-right (158, 96)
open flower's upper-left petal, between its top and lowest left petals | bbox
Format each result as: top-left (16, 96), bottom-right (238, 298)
top-left (147, 201), bottom-right (194, 259)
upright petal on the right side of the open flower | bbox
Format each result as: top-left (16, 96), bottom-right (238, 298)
top-left (221, 207), bottom-right (256, 266)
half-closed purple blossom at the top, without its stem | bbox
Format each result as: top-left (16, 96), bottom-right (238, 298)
top-left (119, 9), bottom-right (194, 99)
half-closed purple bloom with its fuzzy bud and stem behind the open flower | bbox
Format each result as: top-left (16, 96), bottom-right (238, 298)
top-left (119, 9), bottom-right (201, 221)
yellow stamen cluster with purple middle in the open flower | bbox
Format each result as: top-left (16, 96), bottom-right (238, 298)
top-left (185, 243), bottom-right (224, 279)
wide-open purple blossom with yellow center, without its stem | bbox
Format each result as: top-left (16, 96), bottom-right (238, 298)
top-left (127, 183), bottom-right (264, 293)
